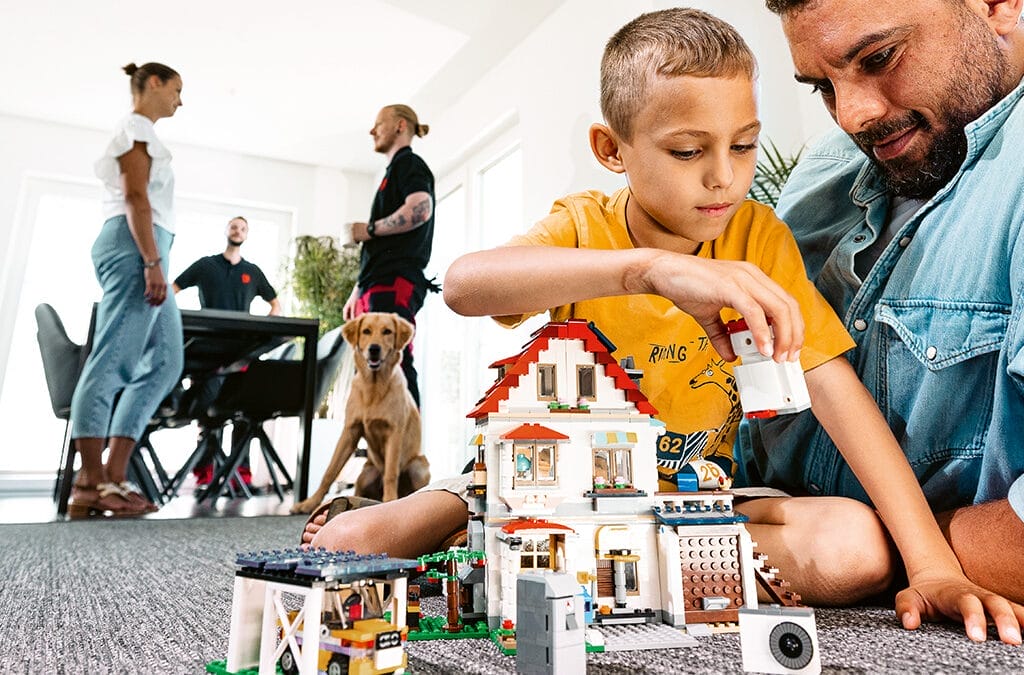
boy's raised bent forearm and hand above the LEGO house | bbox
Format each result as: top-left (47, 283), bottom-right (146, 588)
top-left (443, 246), bottom-right (804, 362)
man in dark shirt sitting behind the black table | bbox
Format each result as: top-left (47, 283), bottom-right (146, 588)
top-left (173, 216), bottom-right (281, 486)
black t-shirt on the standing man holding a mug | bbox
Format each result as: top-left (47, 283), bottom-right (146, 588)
top-left (358, 146), bottom-right (436, 289)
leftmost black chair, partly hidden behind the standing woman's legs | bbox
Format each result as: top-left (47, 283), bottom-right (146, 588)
top-left (36, 302), bottom-right (174, 515)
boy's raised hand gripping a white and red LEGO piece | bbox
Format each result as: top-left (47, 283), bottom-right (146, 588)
top-left (642, 253), bottom-right (804, 363)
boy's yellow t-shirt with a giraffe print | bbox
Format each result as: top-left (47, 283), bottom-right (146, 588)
top-left (497, 187), bottom-right (854, 491)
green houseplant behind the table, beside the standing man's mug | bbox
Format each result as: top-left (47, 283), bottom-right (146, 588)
top-left (289, 235), bottom-right (359, 335)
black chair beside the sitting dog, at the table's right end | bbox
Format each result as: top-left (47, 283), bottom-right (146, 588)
top-left (196, 327), bottom-right (347, 502)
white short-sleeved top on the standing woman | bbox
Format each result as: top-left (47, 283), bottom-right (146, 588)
top-left (95, 113), bottom-right (174, 233)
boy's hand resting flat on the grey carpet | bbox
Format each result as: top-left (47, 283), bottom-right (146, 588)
top-left (896, 577), bottom-right (1024, 644)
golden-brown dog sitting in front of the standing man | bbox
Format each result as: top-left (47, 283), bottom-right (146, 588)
top-left (292, 312), bottom-right (430, 513)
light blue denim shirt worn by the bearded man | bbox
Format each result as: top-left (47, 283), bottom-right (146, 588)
top-left (739, 80), bottom-right (1024, 518)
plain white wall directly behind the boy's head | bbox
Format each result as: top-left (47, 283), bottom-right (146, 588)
top-left (417, 0), bottom-right (833, 234)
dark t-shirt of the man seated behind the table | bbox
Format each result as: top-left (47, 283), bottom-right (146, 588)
top-left (174, 253), bottom-right (278, 311)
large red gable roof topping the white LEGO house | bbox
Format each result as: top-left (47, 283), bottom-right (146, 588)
top-left (466, 319), bottom-right (657, 419)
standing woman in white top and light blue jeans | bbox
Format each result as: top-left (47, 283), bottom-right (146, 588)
top-left (68, 64), bottom-right (182, 517)
